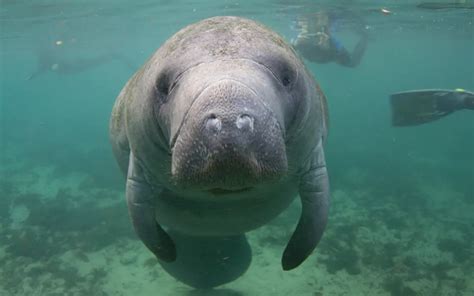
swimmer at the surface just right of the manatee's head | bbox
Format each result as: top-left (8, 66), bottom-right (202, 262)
top-left (292, 10), bottom-right (368, 67)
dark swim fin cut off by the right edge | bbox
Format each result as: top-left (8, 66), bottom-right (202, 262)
top-left (390, 89), bottom-right (474, 126)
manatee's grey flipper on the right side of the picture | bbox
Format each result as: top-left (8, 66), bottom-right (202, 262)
top-left (282, 144), bottom-right (329, 270)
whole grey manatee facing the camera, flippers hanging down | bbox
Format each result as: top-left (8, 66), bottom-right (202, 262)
top-left (110, 17), bottom-right (329, 287)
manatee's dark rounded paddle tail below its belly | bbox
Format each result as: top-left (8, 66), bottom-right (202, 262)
top-left (159, 230), bottom-right (252, 289)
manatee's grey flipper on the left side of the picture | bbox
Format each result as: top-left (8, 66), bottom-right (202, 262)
top-left (126, 153), bottom-right (176, 262)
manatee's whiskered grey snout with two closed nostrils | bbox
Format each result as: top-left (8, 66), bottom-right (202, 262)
top-left (172, 79), bottom-right (287, 191)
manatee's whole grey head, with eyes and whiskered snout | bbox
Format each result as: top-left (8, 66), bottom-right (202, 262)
top-left (144, 18), bottom-right (314, 194)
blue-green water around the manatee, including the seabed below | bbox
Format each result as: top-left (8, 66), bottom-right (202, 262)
top-left (0, 0), bottom-right (474, 296)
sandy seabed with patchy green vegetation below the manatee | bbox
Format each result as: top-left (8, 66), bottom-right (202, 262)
top-left (0, 154), bottom-right (474, 296)
